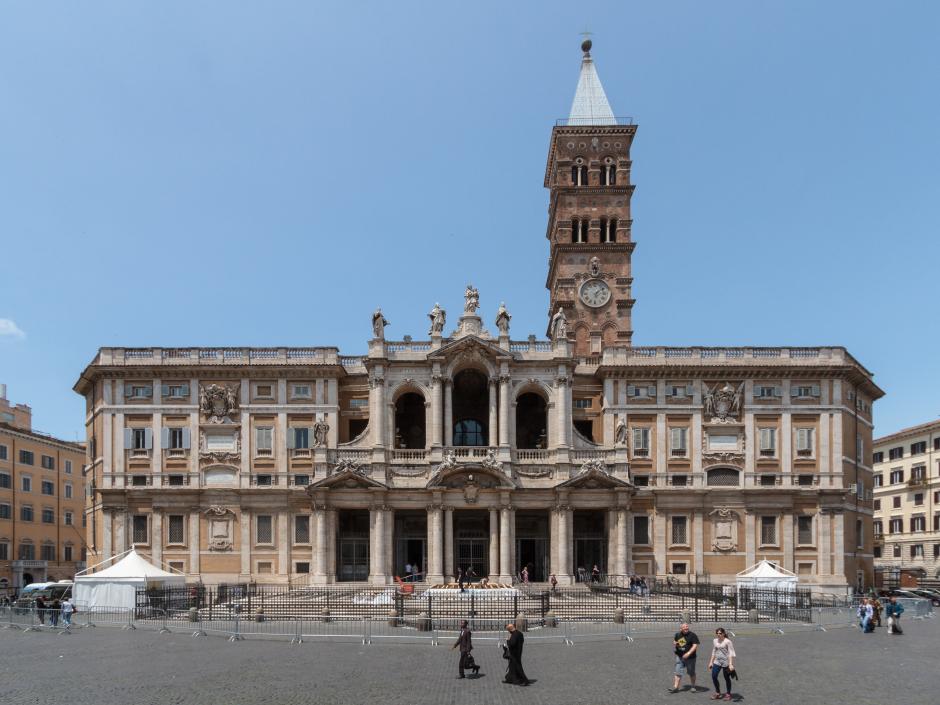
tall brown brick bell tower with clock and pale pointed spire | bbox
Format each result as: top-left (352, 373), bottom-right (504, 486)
top-left (545, 39), bottom-right (636, 355)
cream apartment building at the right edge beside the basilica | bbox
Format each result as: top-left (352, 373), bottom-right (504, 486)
top-left (872, 421), bottom-right (940, 585)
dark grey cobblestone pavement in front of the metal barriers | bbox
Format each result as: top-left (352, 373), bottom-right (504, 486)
top-left (0, 619), bottom-right (940, 705)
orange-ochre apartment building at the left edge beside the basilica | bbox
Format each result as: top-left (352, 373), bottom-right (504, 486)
top-left (0, 384), bottom-right (85, 594)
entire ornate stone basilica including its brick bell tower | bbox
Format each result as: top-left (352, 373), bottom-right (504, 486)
top-left (75, 42), bottom-right (883, 592)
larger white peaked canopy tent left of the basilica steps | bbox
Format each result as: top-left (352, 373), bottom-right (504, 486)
top-left (72, 548), bottom-right (186, 609)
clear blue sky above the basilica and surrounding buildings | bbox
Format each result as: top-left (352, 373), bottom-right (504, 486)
top-left (0, 0), bottom-right (940, 438)
